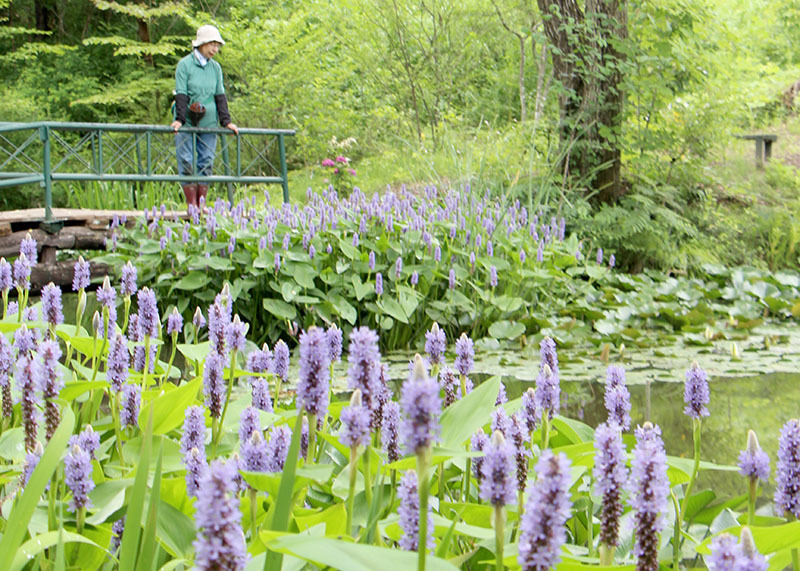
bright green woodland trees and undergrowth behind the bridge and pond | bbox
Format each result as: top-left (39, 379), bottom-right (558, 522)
top-left (0, 0), bottom-right (800, 269)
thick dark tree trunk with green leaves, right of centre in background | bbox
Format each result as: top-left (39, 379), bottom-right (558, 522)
top-left (537, 0), bottom-right (627, 202)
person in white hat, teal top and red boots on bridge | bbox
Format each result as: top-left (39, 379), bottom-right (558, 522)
top-left (172, 26), bottom-right (239, 207)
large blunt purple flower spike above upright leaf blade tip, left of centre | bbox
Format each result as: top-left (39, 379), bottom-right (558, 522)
top-left (297, 327), bottom-right (330, 418)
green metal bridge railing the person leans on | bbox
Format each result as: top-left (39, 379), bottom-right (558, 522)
top-left (0, 121), bottom-right (295, 229)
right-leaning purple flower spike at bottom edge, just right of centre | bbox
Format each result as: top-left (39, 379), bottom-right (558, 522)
top-left (517, 449), bottom-right (571, 571)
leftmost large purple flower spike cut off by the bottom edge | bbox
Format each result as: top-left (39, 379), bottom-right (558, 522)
top-left (193, 460), bottom-right (248, 571)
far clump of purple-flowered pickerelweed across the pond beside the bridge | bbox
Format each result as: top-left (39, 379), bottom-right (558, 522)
top-left (101, 187), bottom-right (614, 348)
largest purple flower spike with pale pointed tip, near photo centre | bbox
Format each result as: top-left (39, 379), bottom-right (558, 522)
top-left (400, 354), bottom-right (442, 454)
